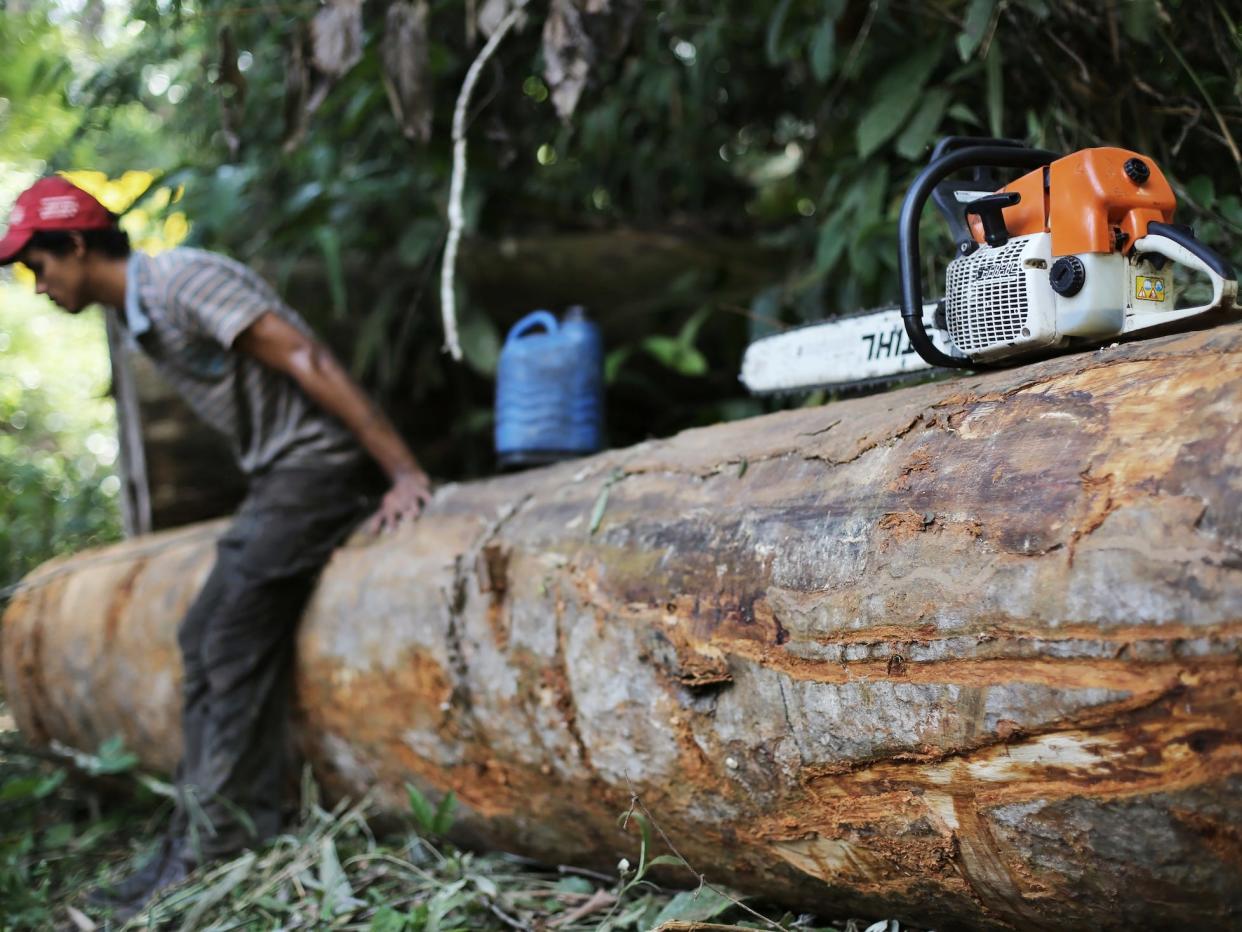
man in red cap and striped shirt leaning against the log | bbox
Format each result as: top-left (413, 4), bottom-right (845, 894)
top-left (0, 176), bottom-right (431, 912)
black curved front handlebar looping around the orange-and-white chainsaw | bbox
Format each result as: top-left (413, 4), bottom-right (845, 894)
top-left (897, 140), bottom-right (1061, 369)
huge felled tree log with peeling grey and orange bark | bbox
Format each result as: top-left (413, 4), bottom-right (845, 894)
top-left (4, 326), bottom-right (1242, 930)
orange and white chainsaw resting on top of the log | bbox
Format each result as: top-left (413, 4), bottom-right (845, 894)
top-left (741, 137), bottom-right (1237, 394)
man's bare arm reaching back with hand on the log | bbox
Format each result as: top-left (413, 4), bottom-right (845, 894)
top-left (233, 311), bottom-right (431, 531)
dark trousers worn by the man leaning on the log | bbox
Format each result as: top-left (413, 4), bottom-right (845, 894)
top-left (173, 467), bottom-right (378, 861)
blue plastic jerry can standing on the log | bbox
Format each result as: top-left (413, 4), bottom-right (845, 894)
top-left (496, 307), bottom-right (604, 467)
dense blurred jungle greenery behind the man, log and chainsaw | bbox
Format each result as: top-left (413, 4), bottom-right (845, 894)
top-left (0, 0), bottom-right (1242, 928)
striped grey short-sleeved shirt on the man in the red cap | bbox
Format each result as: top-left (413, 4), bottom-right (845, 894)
top-left (124, 249), bottom-right (363, 475)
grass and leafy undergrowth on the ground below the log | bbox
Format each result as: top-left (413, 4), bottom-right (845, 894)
top-left (0, 705), bottom-right (914, 932)
